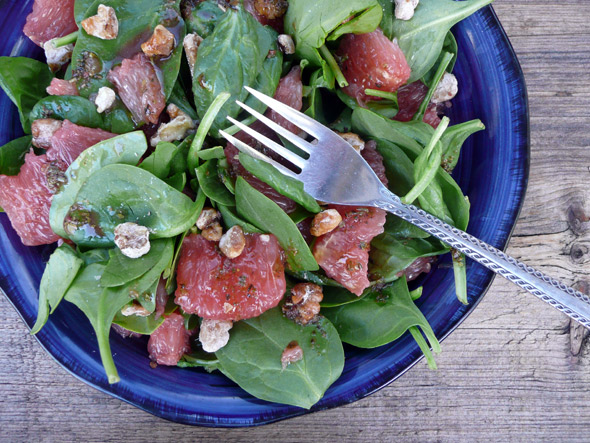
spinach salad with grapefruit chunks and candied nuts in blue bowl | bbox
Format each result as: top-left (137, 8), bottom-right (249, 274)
top-left (0, 0), bottom-right (491, 408)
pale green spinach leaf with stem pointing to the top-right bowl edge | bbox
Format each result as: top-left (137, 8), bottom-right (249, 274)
top-left (396, 0), bottom-right (492, 83)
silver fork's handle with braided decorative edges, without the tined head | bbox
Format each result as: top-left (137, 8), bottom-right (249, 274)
top-left (375, 190), bottom-right (590, 328)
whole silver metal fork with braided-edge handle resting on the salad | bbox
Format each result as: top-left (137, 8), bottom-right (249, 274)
top-left (220, 88), bottom-right (590, 328)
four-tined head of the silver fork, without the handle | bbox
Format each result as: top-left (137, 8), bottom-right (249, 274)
top-left (220, 87), bottom-right (385, 205)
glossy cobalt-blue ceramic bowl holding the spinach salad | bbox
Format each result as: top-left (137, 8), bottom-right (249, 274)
top-left (0, 0), bottom-right (529, 427)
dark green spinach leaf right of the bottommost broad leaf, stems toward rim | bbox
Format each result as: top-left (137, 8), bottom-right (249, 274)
top-left (322, 278), bottom-right (440, 370)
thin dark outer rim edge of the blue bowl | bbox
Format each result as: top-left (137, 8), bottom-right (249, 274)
top-left (0, 5), bottom-right (531, 428)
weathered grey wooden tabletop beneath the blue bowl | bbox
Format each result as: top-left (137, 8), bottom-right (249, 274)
top-left (0, 0), bottom-right (590, 442)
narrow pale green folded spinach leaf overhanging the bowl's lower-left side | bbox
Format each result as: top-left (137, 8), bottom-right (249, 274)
top-left (31, 244), bottom-right (84, 334)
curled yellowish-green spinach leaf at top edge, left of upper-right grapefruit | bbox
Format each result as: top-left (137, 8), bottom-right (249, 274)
top-left (285, 0), bottom-right (382, 66)
